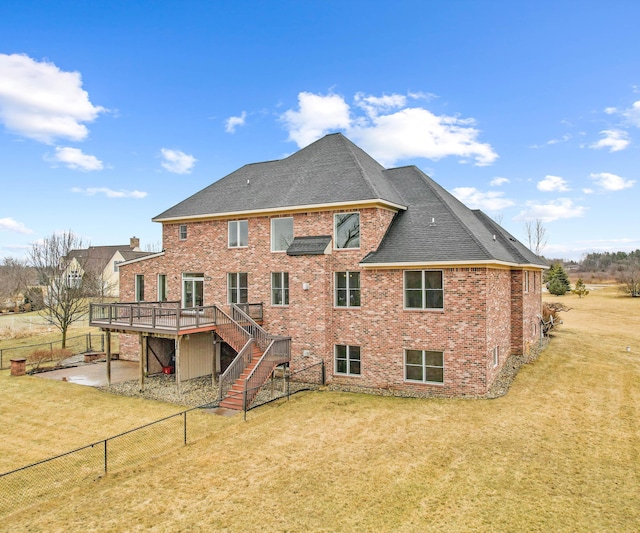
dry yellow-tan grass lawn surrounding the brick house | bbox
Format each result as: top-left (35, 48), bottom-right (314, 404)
top-left (0, 289), bottom-right (640, 532)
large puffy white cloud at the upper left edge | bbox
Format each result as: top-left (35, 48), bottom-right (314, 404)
top-left (0, 54), bottom-right (106, 143)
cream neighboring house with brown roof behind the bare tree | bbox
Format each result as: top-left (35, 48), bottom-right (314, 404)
top-left (64, 237), bottom-right (152, 298)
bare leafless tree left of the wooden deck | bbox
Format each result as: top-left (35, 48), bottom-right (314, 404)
top-left (29, 231), bottom-right (89, 348)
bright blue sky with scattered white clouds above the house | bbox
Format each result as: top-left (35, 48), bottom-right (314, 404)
top-left (0, 0), bottom-right (640, 259)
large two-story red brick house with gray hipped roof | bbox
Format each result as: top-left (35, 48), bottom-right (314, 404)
top-left (92, 134), bottom-right (546, 408)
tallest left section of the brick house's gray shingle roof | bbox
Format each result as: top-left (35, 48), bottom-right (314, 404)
top-left (154, 133), bottom-right (401, 221)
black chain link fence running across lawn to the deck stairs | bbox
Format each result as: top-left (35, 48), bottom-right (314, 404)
top-left (0, 362), bottom-right (324, 517)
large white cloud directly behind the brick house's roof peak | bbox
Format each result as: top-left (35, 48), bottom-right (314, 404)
top-left (281, 92), bottom-right (498, 166)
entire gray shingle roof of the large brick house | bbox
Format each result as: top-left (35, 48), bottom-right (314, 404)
top-left (154, 133), bottom-right (545, 266)
